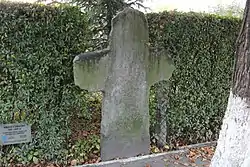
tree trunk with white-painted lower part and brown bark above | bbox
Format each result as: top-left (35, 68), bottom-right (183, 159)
top-left (210, 0), bottom-right (250, 167)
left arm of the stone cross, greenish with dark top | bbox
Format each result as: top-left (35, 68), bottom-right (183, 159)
top-left (73, 48), bottom-right (110, 91)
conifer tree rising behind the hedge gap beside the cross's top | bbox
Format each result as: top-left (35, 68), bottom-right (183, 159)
top-left (40, 0), bottom-right (146, 49)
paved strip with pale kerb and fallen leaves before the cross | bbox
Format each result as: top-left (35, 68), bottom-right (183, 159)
top-left (79, 143), bottom-right (215, 167)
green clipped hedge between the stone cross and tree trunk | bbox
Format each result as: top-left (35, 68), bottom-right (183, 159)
top-left (147, 12), bottom-right (241, 144)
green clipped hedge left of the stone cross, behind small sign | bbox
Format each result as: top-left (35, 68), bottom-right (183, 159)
top-left (0, 3), bottom-right (91, 164)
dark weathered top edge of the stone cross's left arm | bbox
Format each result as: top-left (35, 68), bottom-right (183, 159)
top-left (73, 48), bottom-right (110, 63)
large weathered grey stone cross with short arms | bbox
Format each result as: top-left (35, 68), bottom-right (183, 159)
top-left (73, 8), bottom-right (175, 161)
